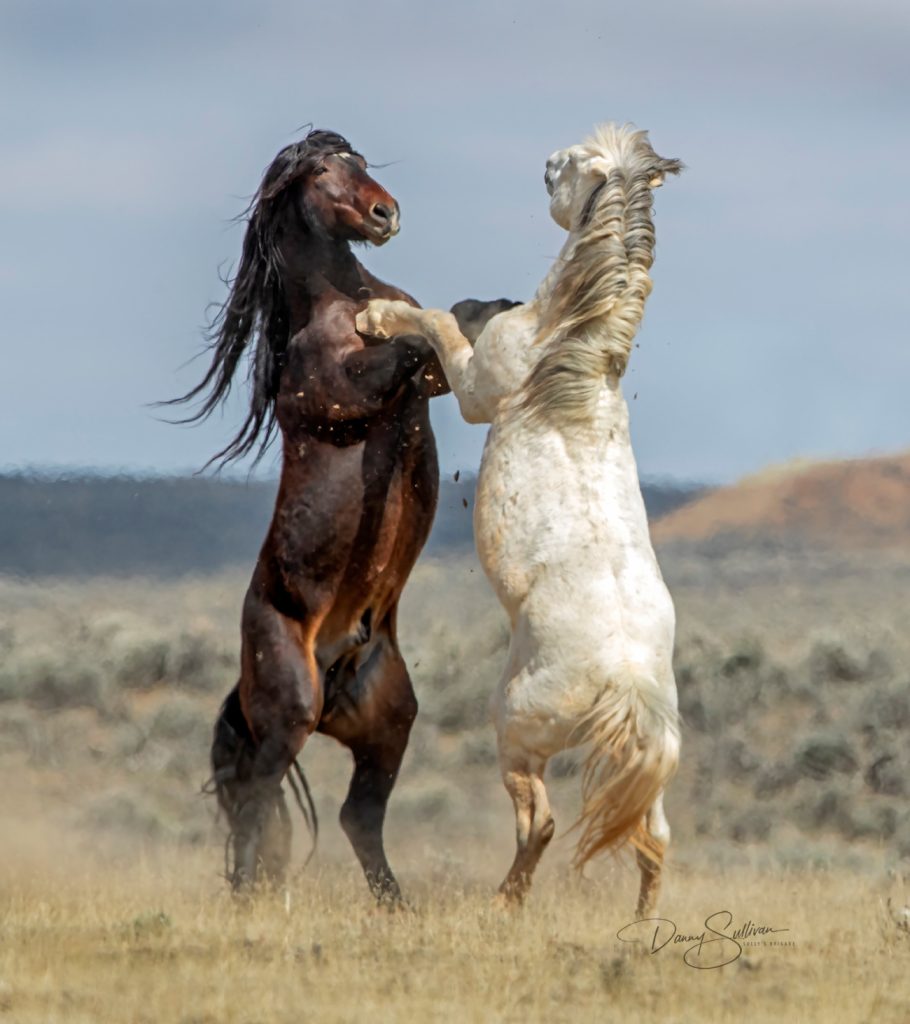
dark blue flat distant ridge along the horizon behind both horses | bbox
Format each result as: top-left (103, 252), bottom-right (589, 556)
top-left (0, 474), bottom-right (700, 578)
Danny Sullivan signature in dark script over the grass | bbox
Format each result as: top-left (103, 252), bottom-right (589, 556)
top-left (616, 910), bottom-right (796, 971)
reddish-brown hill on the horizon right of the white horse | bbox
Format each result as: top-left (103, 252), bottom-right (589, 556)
top-left (652, 452), bottom-right (910, 550)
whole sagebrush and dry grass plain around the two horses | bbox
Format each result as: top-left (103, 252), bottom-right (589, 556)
top-left (0, 552), bottom-right (910, 1024)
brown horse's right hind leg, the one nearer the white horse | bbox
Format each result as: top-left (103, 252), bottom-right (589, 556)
top-left (319, 638), bottom-right (417, 904)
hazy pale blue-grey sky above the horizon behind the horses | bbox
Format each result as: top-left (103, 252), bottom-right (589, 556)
top-left (0, 0), bottom-right (910, 480)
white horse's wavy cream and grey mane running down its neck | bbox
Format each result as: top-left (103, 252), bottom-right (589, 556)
top-left (522, 124), bottom-right (683, 423)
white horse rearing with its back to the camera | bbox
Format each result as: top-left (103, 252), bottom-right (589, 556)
top-left (357, 124), bottom-right (682, 914)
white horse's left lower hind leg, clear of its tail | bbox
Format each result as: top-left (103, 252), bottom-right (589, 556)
top-left (500, 757), bottom-right (556, 903)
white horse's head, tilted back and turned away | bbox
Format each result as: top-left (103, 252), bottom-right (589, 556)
top-left (544, 123), bottom-right (682, 231)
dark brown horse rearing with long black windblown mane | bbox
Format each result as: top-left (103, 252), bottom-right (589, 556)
top-left (169, 131), bottom-right (447, 901)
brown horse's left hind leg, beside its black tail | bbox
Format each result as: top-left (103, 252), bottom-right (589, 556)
top-left (212, 594), bottom-right (321, 890)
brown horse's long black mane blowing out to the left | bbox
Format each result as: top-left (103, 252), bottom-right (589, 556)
top-left (165, 130), bottom-right (359, 466)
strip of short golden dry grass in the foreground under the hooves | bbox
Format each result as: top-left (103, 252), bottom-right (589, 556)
top-left (0, 852), bottom-right (910, 1024)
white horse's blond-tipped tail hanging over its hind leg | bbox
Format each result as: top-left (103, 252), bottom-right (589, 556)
top-left (574, 666), bottom-right (680, 869)
